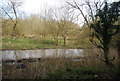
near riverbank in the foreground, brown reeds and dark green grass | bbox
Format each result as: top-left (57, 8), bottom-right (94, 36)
top-left (3, 58), bottom-right (119, 81)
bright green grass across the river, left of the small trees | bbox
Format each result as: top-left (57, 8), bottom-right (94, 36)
top-left (2, 38), bottom-right (58, 49)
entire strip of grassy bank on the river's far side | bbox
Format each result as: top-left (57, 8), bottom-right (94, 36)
top-left (2, 38), bottom-right (90, 50)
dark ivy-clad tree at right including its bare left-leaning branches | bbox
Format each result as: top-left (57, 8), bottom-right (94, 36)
top-left (68, 0), bottom-right (120, 67)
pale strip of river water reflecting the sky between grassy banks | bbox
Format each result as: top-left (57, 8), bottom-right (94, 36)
top-left (2, 49), bottom-right (83, 60)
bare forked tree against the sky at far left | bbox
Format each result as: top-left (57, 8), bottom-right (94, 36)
top-left (1, 0), bottom-right (23, 36)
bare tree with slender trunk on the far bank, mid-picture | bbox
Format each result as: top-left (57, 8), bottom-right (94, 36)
top-left (59, 6), bottom-right (77, 46)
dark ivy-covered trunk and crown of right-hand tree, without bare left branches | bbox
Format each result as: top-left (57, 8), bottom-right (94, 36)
top-left (90, 1), bottom-right (120, 67)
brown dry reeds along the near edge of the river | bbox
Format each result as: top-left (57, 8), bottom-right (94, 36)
top-left (3, 49), bottom-right (118, 79)
